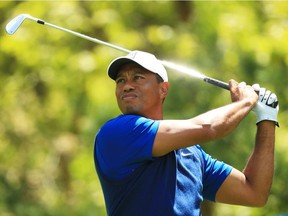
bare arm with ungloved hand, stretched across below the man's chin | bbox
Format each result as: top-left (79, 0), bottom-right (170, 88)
top-left (152, 80), bottom-right (258, 157)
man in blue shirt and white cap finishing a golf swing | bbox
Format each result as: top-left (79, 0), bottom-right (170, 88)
top-left (94, 51), bottom-right (278, 216)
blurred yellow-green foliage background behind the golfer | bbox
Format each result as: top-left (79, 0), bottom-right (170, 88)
top-left (0, 1), bottom-right (288, 216)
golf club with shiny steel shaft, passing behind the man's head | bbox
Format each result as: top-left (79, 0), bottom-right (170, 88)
top-left (6, 14), bottom-right (229, 90)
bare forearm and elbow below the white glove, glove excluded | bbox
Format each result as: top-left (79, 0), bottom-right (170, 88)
top-left (216, 121), bottom-right (275, 207)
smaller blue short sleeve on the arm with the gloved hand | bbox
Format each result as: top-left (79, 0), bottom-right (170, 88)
top-left (199, 147), bottom-right (232, 202)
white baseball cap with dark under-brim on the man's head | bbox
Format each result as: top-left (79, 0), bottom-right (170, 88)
top-left (108, 50), bottom-right (168, 82)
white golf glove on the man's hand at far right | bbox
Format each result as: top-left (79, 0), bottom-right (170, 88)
top-left (252, 84), bottom-right (279, 127)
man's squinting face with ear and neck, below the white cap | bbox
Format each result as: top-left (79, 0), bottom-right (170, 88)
top-left (115, 63), bottom-right (168, 119)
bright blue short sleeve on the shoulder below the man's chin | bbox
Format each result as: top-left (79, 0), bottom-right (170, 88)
top-left (95, 115), bottom-right (159, 180)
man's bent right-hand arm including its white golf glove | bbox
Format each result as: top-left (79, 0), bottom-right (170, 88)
top-left (216, 84), bottom-right (279, 206)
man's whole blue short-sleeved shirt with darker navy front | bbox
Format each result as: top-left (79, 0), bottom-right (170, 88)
top-left (94, 115), bottom-right (232, 216)
